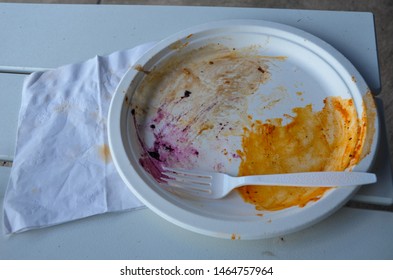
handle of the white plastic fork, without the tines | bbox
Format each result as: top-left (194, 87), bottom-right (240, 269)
top-left (237, 171), bottom-right (377, 187)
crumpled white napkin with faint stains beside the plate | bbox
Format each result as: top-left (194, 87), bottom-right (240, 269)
top-left (3, 43), bottom-right (154, 234)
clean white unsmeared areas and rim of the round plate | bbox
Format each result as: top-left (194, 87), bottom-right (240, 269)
top-left (108, 20), bottom-right (378, 239)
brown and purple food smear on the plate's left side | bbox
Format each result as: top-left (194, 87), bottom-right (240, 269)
top-left (131, 44), bottom-right (278, 181)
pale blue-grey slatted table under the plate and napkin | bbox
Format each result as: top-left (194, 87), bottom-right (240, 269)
top-left (0, 4), bottom-right (393, 259)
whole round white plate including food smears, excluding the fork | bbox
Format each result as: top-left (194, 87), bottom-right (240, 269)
top-left (108, 20), bottom-right (378, 239)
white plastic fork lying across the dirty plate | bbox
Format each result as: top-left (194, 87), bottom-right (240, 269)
top-left (161, 167), bottom-right (377, 199)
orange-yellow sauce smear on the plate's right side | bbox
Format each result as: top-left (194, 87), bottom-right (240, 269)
top-left (238, 97), bottom-right (364, 211)
